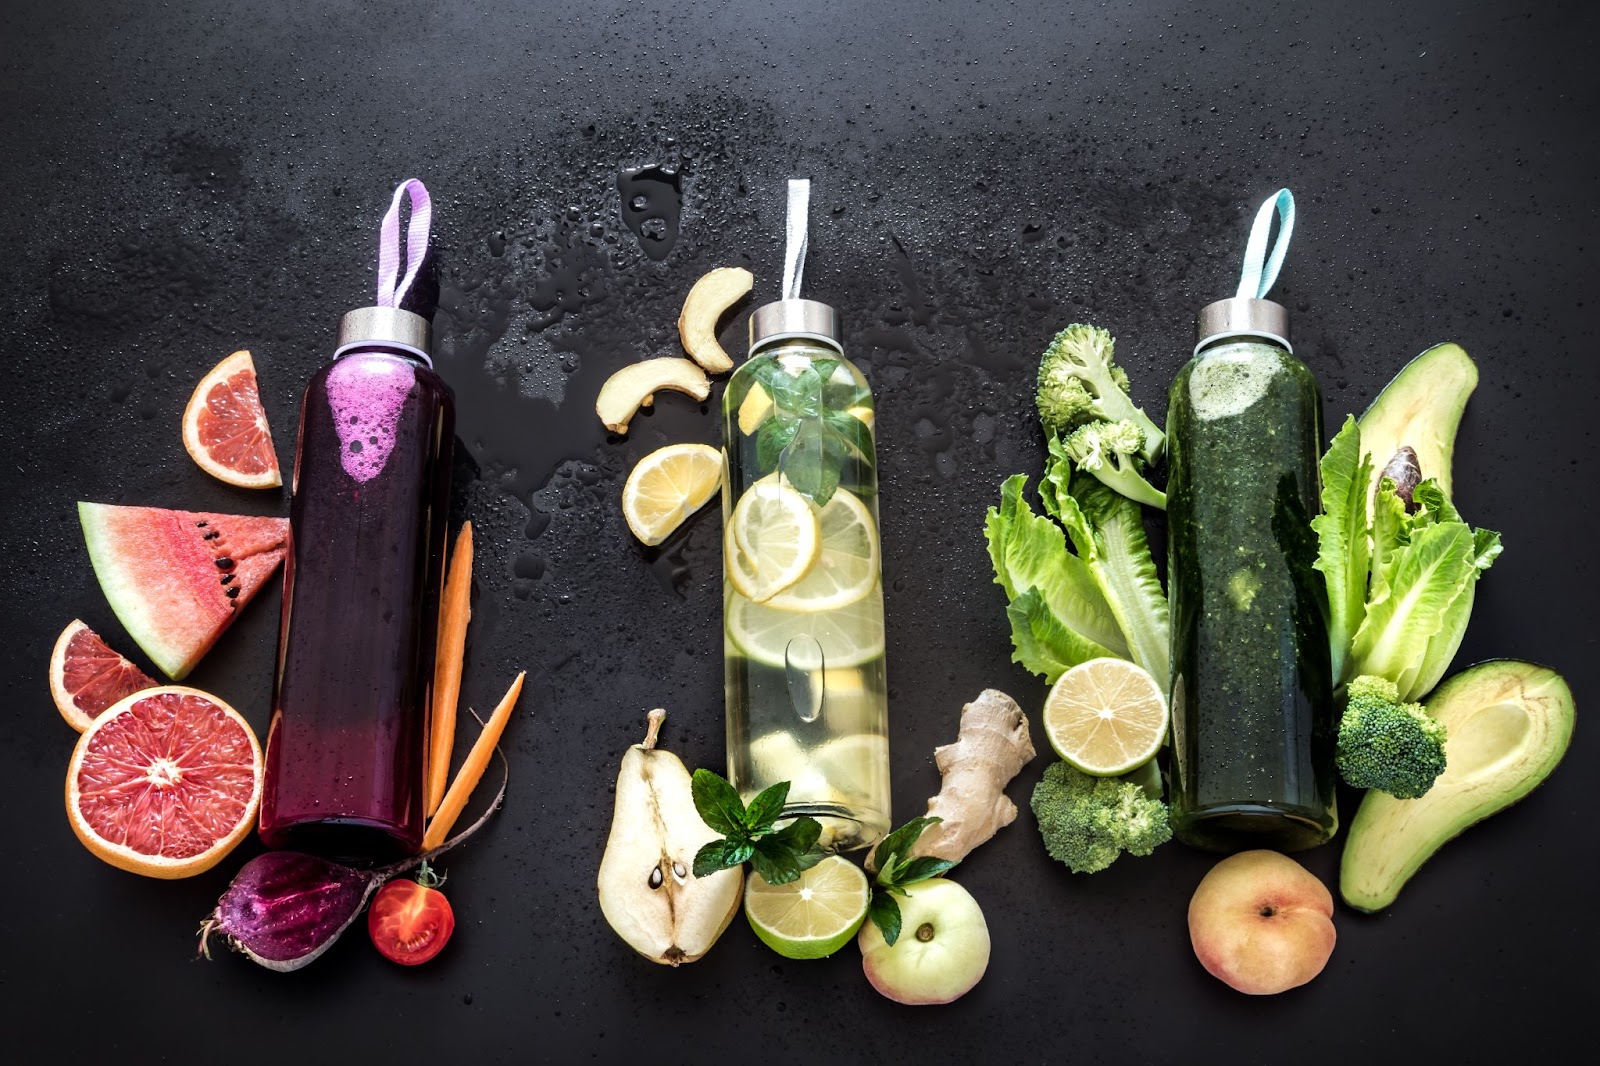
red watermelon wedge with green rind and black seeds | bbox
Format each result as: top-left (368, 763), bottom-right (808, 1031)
top-left (78, 503), bottom-right (290, 680)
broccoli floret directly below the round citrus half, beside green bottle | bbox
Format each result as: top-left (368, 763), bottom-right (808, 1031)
top-left (1032, 762), bottom-right (1173, 874)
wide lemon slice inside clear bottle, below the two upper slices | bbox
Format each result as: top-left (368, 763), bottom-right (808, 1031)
top-left (723, 585), bottom-right (883, 671)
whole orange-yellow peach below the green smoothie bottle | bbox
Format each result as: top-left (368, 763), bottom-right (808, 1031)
top-left (1189, 850), bottom-right (1334, 996)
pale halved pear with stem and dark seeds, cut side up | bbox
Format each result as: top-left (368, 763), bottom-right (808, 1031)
top-left (598, 707), bottom-right (744, 967)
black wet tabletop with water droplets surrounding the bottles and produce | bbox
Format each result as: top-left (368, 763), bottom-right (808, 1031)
top-left (0, 0), bottom-right (1600, 1063)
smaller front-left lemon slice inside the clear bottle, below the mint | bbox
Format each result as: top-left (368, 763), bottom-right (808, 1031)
top-left (723, 477), bottom-right (822, 603)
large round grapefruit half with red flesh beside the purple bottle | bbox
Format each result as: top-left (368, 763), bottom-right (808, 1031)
top-left (67, 685), bottom-right (261, 879)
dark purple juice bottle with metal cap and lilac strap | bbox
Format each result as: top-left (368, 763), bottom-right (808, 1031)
top-left (261, 181), bottom-right (456, 861)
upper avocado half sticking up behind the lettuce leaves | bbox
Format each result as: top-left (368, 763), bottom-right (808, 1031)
top-left (1358, 344), bottom-right (1478, 499)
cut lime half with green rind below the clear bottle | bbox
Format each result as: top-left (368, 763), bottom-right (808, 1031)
top-left (744, 855), bottom-right (872, 959)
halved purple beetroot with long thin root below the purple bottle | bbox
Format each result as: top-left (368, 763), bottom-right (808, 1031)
top-left (200, 765), bottom-right (506, 972)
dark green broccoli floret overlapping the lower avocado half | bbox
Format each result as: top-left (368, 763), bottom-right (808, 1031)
top-left (1339, 675), bottom-right (1445, 799)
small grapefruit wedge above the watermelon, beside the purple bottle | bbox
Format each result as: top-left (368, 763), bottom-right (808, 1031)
top-left (184, 351), bottom-right (283, 488)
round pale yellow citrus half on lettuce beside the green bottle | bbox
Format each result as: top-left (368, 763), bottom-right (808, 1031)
top-left (1045, 658), bottom-right (1166, 778)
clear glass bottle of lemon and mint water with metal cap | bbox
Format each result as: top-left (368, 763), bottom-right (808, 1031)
top-left (723, 299), bottom-right (890, 852)
